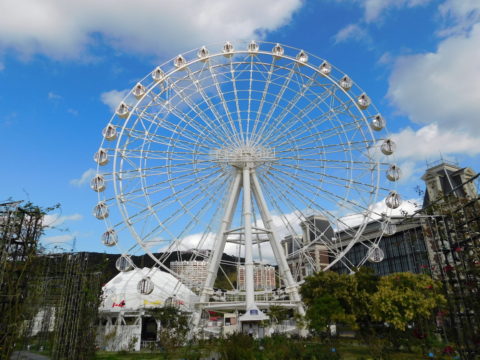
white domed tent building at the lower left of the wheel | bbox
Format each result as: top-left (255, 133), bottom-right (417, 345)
top-left (97, 268), bottom-right (198, 351)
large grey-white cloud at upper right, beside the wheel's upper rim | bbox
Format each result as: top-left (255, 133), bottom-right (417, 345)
top-left (388, 24), bottom-right (480, 135)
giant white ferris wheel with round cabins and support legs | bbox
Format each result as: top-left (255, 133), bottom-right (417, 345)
top-left (91, 41), bottom-right (401, 324)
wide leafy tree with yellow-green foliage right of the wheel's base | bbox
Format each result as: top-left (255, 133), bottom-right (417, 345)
top-left (301, 268), bottom-right (445, 358)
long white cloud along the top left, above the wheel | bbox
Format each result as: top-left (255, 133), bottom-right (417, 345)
top-left (0, 0), bottom-right (302, 58)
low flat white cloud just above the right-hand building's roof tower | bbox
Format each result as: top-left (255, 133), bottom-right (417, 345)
top-left (392, 123), bottom-right (480, 161)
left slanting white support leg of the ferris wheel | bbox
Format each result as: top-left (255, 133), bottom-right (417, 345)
top-left (193, 171), bottom-right (242, 329)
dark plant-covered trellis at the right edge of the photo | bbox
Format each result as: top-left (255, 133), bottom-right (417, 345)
top-left (422, 174), bottom-right (480, 359)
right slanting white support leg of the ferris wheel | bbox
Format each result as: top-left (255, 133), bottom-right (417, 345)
top-left (251, 170), bottom-right (305, 316)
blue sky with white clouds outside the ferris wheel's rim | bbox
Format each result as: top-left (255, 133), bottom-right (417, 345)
top-left (0, 0), bottom-right (480, 251)
